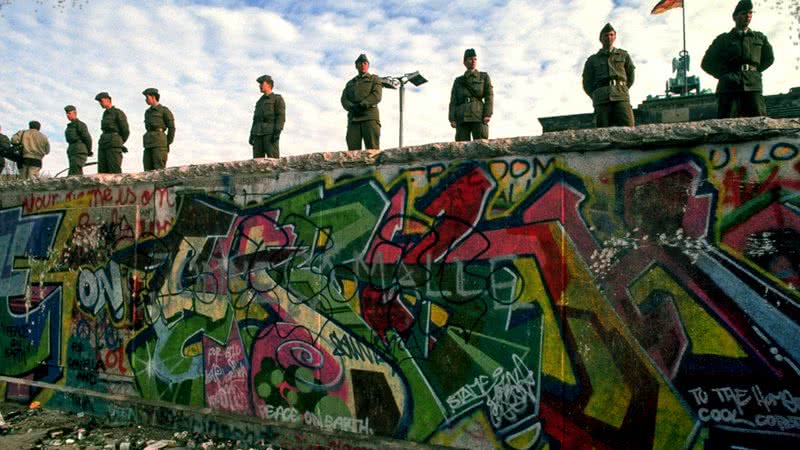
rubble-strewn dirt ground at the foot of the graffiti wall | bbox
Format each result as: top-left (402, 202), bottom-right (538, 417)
top-left (0, 403), bottom-right (279, 450)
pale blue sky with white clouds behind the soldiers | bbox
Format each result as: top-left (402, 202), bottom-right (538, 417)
top-left (0, 0), bottom-right (800, 174)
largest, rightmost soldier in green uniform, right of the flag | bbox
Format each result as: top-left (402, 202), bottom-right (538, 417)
top-left (700, 0), bottom-right (775, 119)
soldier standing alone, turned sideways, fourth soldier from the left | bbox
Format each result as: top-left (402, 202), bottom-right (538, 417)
top-left (250, 75), bottom-right (286, 158)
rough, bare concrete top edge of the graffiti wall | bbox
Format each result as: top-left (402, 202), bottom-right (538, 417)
top-left (0, 117), bottom-right (800, 192)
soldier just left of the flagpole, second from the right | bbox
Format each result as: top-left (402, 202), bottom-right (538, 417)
top-left (583, 23), bottom-right (636, 128)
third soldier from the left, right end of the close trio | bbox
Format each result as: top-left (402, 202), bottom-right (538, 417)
top-left (142, 88), bottom-right (175, 172)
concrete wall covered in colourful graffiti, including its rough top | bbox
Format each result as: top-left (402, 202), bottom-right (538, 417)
top-left (0, 119), bottom-right (800, 449)
